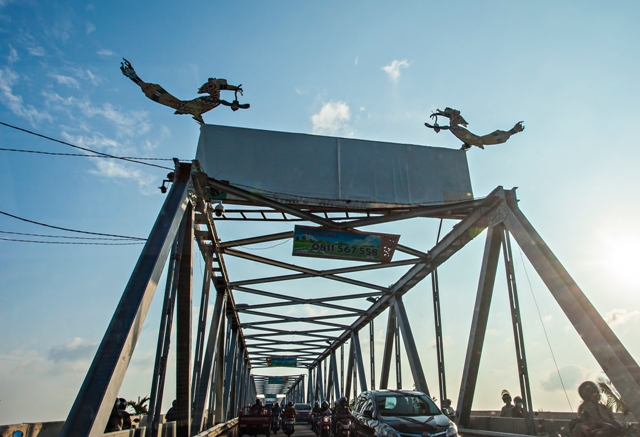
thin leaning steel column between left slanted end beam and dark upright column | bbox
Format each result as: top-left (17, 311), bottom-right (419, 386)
top-left (147, 220), bottom-right (185, 437)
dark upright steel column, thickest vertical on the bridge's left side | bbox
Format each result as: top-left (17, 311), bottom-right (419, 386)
top-left (176, 203), bottom-right (194, 437)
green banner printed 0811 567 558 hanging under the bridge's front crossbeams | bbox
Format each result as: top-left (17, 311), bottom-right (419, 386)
top-left (293, 226), bottom-right (400, 263)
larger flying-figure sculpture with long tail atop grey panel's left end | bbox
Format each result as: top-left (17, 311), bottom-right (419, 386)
top-left (120, 58), bottom-right (249, 124)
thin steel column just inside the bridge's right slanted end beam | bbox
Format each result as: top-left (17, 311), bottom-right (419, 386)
top-left (497, 224), bottom-right (536, 435)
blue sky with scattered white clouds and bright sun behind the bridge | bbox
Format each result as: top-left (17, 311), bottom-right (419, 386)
top-left (0, 0), bottom-right (640, 423)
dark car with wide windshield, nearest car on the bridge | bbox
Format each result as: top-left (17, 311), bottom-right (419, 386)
top-left (353, 390), bottom-right (458, 437)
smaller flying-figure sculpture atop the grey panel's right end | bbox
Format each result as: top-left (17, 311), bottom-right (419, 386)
top-left (424, 108), bottom-right (524, 151)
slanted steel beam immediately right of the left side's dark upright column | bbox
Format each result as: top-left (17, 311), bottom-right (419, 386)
top-left (191, 284), bottom-right (227, 435)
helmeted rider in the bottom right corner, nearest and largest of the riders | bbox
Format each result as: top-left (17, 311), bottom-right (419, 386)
top-left (569, 381), bottom-right (626, 437)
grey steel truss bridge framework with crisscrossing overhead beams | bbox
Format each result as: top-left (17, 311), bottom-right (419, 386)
top-left (61, 146), bottom-right (640, 437)
